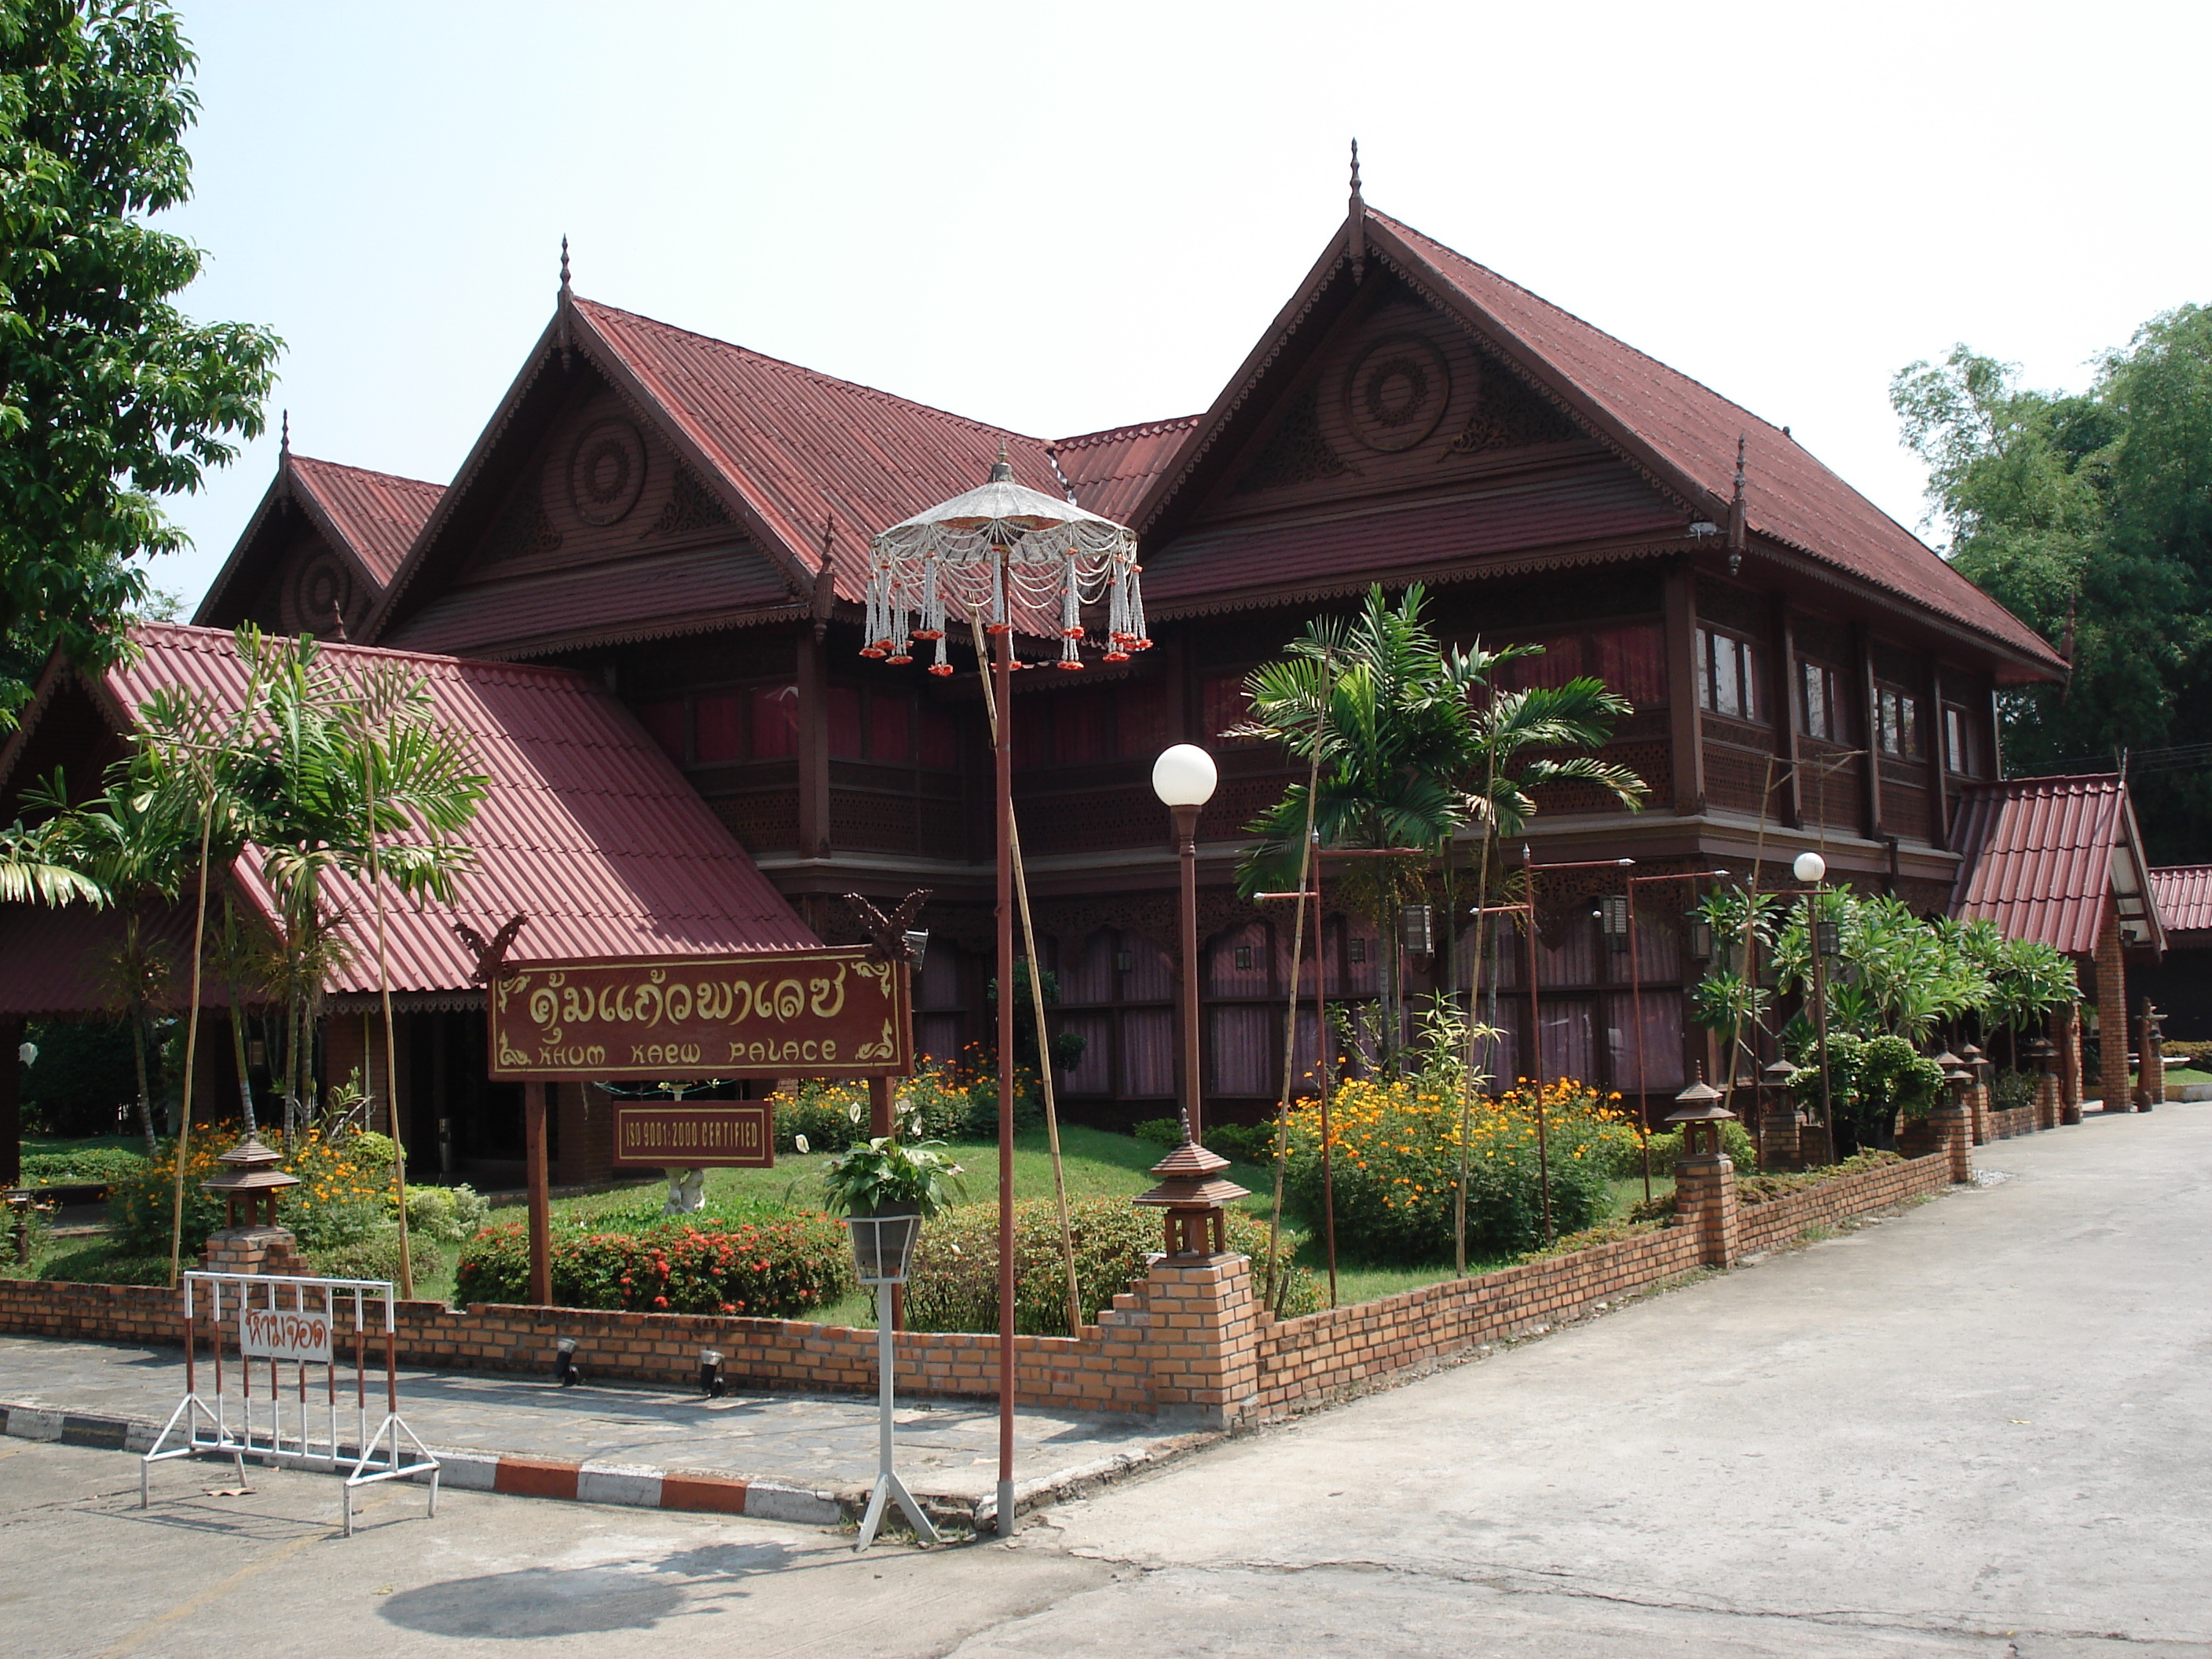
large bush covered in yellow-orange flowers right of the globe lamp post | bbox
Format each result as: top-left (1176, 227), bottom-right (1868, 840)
top-left (1287, 1077), bottom-right (1635, 1263)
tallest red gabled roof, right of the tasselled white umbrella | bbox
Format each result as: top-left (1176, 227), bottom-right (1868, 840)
top-left (1135, 203), bottom-right (2066, 679)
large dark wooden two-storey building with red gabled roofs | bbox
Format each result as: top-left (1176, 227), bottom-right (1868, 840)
top-left (0, 195), bottom-right (2062, 1185)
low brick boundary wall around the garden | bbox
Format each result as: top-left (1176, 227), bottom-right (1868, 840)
top-left (0, 1159), bottom-right (1972, 1426)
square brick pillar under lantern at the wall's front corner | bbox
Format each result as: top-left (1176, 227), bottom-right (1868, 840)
top-left (1132, 1256), bottom-right (1258, 1429)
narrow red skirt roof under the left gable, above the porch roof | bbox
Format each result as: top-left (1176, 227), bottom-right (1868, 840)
top-left (383, 547), bottom-right (792, 657)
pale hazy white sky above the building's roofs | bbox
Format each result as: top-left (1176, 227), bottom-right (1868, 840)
top-left (152, 0), bottom-right (2212, 604)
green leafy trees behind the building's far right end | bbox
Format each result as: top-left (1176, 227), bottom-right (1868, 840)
top-left (1889, 306), bottom-right (2212, 862)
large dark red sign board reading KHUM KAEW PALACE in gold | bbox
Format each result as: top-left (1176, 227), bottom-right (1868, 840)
top-left (487, 947), bottom-right (914, 1082)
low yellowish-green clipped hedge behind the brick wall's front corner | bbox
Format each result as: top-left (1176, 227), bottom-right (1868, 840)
top-left (907, 1199), bottom-right (1320, 1336)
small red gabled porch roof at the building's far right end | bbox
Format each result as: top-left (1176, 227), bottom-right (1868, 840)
top-left (1951, 772), bottom-right (2166, 956)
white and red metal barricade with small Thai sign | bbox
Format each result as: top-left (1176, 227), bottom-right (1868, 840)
top-left (139, 1272), bottom-right (438, 1537)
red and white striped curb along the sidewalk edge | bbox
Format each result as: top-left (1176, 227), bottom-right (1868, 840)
top-left (0, 1404), bottom-right (848, 1526)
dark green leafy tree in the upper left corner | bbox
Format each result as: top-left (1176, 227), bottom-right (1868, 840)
top-left (0, 0), bottom-right (279, 710)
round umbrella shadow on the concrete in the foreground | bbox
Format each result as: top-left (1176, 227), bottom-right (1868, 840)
top-left (379, 1544), bottom-right (792, 1641)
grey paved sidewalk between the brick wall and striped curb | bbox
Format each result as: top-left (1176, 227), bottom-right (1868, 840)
top-left (0, 1336), bottom-right (1217, 1518)
